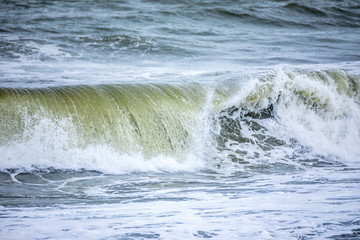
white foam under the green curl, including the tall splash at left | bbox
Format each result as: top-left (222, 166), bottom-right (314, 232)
top-left (0, 114), bottom-right (205, 173)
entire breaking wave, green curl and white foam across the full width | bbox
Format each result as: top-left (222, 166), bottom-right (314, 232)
top-left (0, 69), bottom-right (360, 172)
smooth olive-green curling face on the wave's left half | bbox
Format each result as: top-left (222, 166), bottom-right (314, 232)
top-left (0, 84), bottom-right (208, 172)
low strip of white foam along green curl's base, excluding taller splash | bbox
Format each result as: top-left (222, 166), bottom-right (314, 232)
top-left (0, 141), bottom-right (205, 174)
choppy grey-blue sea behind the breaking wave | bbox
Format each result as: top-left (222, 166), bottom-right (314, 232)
top-left (0, 1), bottom-right (360, 86)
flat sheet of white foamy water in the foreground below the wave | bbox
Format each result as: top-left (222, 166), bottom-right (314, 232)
top-left (0, 172), bottom-right (359, 239)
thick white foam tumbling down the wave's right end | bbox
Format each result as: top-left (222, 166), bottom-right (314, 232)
top-left (275, 70), bottom-right (360, 161)
